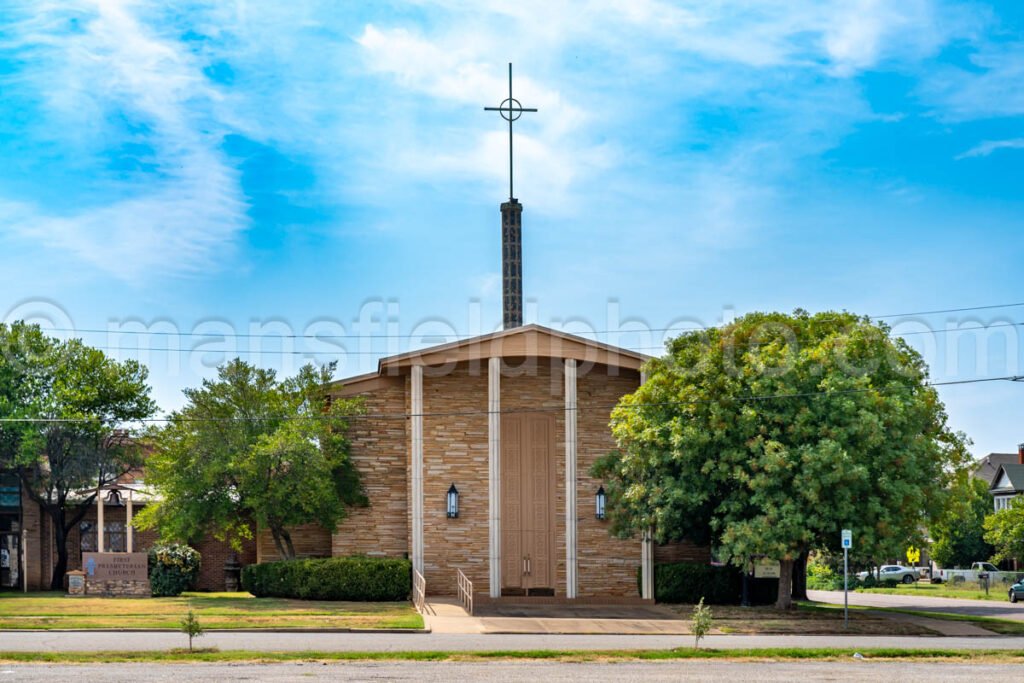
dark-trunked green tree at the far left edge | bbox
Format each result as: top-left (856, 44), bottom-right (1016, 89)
top-left (0, 323), bottom-right (157, 590)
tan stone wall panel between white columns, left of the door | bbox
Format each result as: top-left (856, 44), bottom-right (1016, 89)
top-left (419, 362), bottom-right (491, 595)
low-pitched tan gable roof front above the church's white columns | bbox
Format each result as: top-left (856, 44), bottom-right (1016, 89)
top-left (338, 324), bottom-right (651, 393)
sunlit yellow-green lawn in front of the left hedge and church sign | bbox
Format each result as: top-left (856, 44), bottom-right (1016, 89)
top-left (0, 593), bottom-right (423, 630)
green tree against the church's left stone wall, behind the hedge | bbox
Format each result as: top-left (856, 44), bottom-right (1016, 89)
top-left (139, 359), bottom-right (366, 559)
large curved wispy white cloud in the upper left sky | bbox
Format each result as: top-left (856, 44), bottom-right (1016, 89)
top-left (0, 0), bottom-right (247, 281)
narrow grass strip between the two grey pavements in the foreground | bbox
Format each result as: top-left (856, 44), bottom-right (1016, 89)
top-left (0, 647), bottom-right (1024, 664)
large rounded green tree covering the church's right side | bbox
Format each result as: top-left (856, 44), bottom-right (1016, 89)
top-left (594, 310), bottom-right (968, 608)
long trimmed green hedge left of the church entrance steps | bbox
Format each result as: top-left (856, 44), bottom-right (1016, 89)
top-left (242, 557), bottom-right (413, 602)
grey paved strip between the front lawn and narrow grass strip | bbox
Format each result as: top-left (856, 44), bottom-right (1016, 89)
top-left (0, 631), bottom-right (1024, 652)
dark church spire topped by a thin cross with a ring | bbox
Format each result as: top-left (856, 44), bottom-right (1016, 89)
top-left (483, 63), bottom-right (537, 330)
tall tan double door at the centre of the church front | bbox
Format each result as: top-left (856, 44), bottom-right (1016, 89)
top-left (501, 414), bottom-right (556, 595)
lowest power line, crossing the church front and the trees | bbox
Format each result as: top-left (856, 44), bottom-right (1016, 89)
top-left (0, 375), bottom-right (1007, 424)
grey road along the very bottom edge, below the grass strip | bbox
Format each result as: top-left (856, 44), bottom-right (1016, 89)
top-left (0, 659), bottom-right (1020, 683)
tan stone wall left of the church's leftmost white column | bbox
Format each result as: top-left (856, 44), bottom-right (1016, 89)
top-left (331, 378), bottom-right (410, 557)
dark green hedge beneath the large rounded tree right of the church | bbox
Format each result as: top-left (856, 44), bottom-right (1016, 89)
top-left (637, 562), bottom-right (778, 605)
